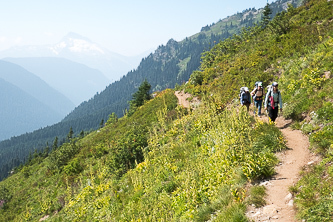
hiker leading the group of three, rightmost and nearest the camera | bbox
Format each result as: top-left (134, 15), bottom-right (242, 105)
top-left (265, 82), bottom-right (282, 122)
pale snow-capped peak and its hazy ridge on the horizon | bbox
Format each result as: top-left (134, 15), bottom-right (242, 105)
top-left (0, 33), bottom-right (146, 82)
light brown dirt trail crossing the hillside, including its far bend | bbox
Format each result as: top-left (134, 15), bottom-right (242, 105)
top-left (175, 92), bottom-right (319, 222)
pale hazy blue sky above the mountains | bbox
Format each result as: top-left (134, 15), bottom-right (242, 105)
top-left (0, 0), bottom-right (272, 55)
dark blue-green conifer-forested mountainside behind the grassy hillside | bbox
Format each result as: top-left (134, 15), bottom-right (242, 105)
top-left (0, 1), bottom-right (298, 182)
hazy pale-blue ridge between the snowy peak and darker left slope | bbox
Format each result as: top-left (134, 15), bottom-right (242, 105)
top-left (4, 57), bottom-right (110, 106)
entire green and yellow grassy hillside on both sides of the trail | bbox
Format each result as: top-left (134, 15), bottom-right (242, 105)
top-left (0, 0), bottom-right (333, 221)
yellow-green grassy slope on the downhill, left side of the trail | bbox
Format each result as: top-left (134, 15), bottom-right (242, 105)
top-left (0, 90), bottom-right (284, 221)
